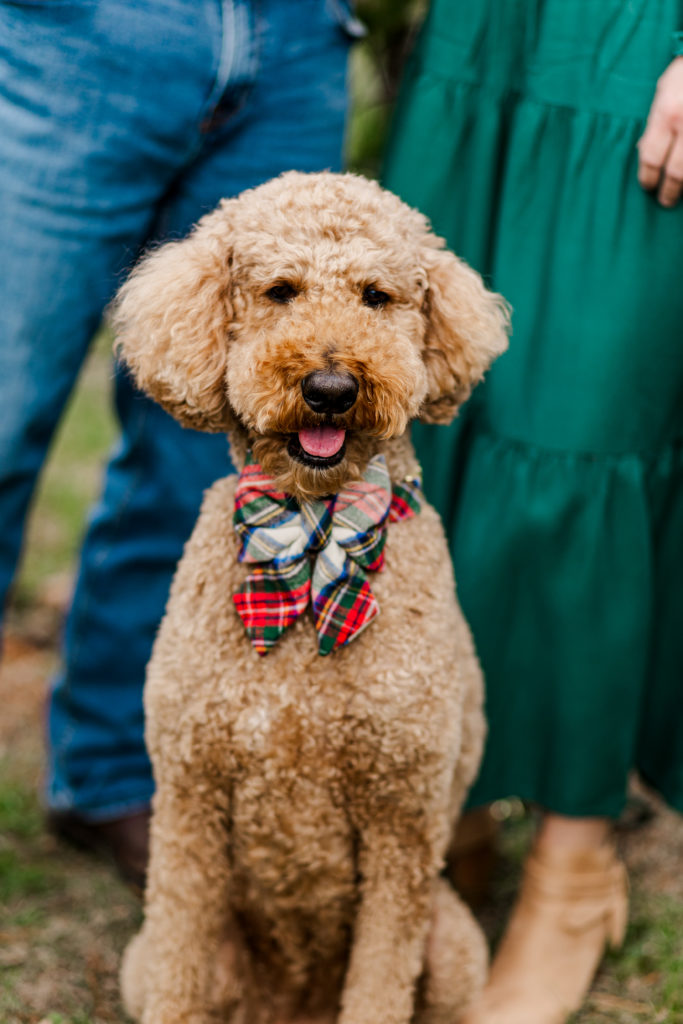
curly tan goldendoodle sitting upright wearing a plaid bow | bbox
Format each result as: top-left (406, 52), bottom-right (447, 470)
top-left (114, 173), bottom-right (508, 1024)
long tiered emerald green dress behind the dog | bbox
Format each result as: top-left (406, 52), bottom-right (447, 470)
top-left (385, 0), bottom-right (683, 816)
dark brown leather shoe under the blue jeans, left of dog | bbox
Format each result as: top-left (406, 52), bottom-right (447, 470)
top-left (45, 810), bottom-right (150, 896)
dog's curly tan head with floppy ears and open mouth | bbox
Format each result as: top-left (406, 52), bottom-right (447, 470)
top-left (115, 172), bottom-right (508, 497)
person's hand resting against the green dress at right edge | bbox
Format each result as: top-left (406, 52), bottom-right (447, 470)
top-left (638, 56), bottom-right (683, 207)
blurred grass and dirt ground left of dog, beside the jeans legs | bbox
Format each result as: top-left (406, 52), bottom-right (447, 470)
top-left (0, 332), bottom-right (140, 1024)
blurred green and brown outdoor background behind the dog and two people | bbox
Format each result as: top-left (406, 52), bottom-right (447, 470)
top-left (0, 0), bottom-right (683, 1024)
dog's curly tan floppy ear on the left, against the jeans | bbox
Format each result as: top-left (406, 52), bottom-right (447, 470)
top-left (112, 201), bottom-right (232, 432)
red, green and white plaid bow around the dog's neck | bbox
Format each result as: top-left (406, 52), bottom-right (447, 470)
top-left (232, 455), bottom-right (420, 654)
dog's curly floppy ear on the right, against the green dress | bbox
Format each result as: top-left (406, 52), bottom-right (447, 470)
top-left (420, 243), bottom-right (510, 423)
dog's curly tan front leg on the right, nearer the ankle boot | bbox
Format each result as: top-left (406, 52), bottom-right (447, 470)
top-left (339, 816), bottom-right (443, 1024)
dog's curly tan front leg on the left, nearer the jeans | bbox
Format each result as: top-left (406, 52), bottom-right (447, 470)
top-left (122, 777), bottom-right (240, 1024)
